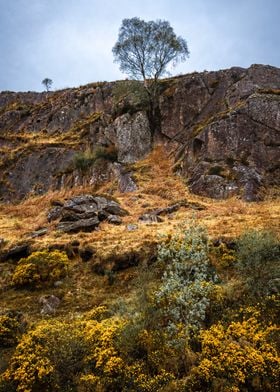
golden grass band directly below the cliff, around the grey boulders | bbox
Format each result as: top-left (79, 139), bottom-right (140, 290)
top-left (0, 146), bottom-right (280, 253)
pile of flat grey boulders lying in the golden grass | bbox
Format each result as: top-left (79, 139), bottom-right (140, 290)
top-left (48, 195), bottom-right (128, 233)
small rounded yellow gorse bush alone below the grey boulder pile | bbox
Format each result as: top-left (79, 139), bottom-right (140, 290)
top-left (12, 250), bottom-right (69, 289)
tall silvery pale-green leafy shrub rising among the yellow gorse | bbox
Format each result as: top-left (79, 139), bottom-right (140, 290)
top-left (155, 224), bottom-right (216, 340)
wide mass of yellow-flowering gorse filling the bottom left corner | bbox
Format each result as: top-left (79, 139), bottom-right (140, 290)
top-left (0, 317), bottom-right (173, 392)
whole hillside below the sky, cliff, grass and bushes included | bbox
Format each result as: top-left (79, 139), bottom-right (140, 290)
top-left (0, 65), bottom-right (280, 392)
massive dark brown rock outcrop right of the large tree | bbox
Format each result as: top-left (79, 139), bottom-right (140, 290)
top-left (161, 65), bottom-right (280, 201)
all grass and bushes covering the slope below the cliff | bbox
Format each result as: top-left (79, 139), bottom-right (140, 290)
top-left (0, 149), bottom-right (280, 392)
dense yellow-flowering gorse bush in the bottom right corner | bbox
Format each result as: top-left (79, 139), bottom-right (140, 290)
top-left (187, 316), bottom-right (280, 392)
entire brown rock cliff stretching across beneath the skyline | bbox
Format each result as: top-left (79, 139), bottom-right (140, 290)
top-left (0, 65), bottom-right (280, 201)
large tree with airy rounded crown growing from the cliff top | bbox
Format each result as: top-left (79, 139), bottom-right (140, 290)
top-left (112, 18), bottom-right (189, 132)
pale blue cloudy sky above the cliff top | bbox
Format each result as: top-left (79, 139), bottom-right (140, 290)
top-left (0, 0), bottom-right (280, 91)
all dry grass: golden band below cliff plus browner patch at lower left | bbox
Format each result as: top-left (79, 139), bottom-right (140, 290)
top-left (0, 147), bottom-right (280, 322)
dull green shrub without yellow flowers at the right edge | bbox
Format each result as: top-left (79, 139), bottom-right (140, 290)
top-left (237, 230), bottom-right (280, 298)
